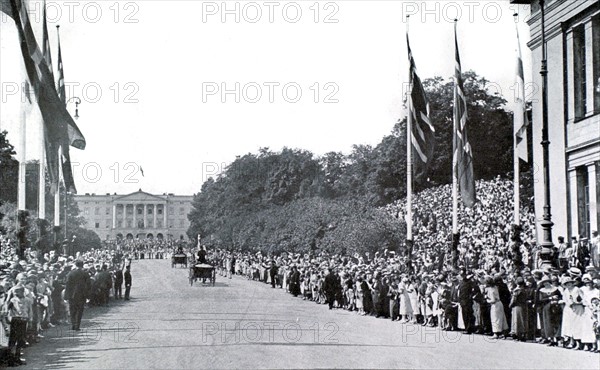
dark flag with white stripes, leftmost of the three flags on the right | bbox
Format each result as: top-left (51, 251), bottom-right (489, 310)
top-left (406, 33), bottom-right (435, 181)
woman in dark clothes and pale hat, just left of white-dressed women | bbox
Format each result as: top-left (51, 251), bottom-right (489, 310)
top-left (538, 277), bottom-right (562, 347)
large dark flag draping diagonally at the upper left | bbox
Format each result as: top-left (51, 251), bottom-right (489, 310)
top-left (2, 0), bottom-right (85, 191)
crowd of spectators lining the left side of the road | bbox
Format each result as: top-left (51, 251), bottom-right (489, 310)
top-left (0, 235), bottom-right (132, 367)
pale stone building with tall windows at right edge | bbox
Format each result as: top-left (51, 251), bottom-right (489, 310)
top-left (511, 0), bottom-right (600, 241)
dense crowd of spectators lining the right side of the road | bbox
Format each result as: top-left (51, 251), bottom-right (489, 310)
top-left (200, 179), bottom-right (600, 351)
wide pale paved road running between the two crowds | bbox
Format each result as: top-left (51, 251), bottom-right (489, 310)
top-left (26, 260), bottom-right (600, 369)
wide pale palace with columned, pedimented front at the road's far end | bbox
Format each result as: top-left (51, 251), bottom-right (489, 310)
top-left (74, 189), bottom-right (193, 240)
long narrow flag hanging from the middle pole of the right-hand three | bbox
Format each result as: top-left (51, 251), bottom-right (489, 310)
top-left (452, 23), bottom-right (477, 207)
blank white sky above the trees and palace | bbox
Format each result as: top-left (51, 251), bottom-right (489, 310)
top-left (0, 0), bottom-right (532, 195)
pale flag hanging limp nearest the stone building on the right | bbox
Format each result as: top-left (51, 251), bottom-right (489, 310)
top-left (513, 23), bottom-right (529, 162)
